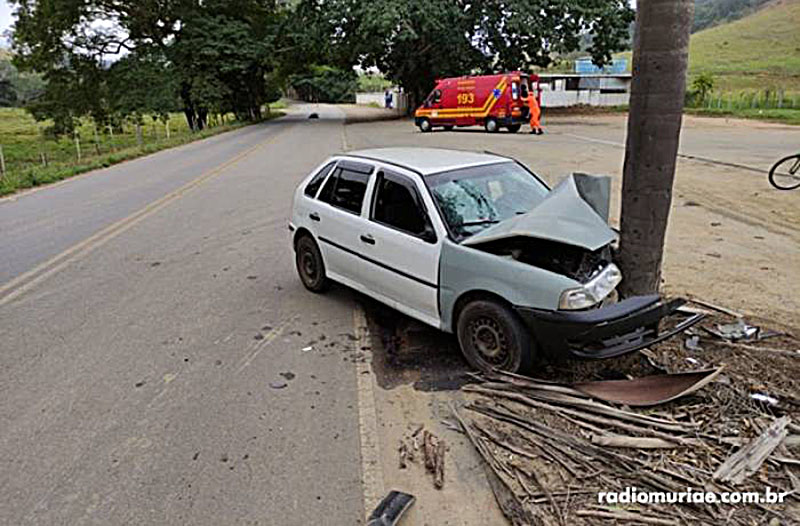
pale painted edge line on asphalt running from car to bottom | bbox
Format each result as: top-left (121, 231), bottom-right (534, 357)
top-left (353, 304), bottom-right (384, 515)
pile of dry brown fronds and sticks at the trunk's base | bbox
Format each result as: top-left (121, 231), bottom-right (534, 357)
top-left (452, 314), bottom-right (800, 526)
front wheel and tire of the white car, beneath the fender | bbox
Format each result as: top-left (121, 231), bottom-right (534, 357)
top-left (456, 300), bottom-right (534, 373)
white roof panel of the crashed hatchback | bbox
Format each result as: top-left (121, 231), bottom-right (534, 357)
top-left (344, 147), bottom-right (510, 175)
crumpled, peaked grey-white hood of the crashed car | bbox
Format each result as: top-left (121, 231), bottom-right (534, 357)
top-left (462, 175), bottom-right (617, 251)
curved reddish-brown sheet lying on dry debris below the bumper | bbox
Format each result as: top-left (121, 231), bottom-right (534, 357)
top-left (572, 367), bottom-right (723, 407)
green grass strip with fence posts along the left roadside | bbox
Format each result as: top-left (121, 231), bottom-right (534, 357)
top-left (0, 107), bottom-right (282, 195)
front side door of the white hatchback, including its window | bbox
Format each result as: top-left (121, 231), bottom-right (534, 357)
top-left (359, 169), bottom-right (442, 327)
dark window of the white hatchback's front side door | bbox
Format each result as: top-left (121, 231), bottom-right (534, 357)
top-left (372, 172), bottom-right (428, 236)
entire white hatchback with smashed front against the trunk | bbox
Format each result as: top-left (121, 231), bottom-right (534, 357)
top-left (289, 148), bottom-right (700, 372)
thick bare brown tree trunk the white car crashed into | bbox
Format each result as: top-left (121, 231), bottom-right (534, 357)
top-left (619, 0), bottom-right (694, 296)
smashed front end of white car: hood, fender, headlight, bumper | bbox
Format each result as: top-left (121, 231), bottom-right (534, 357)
top-left (441, 173), bottom-right (702, 359)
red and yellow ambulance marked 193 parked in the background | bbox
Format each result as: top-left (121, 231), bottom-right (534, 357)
top-left (414, 71), bottom-right (539, 133)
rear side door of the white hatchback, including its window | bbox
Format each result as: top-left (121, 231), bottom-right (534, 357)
top-left (310, 160), bottom-right (374, 288)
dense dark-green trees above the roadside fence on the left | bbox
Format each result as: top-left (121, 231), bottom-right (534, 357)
top-left (12, 0), bottom-right (287, 129)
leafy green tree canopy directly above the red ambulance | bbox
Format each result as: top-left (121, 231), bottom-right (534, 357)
top-left (304, 0), bottom-right (633, 108)
